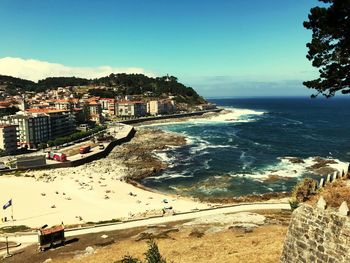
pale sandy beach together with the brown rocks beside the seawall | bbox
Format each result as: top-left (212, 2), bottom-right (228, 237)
top-left (0, 124), bottom-right (213, 228)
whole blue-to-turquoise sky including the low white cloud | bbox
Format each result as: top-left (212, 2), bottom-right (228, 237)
top-left (0, 0), bottom-right (319, 97)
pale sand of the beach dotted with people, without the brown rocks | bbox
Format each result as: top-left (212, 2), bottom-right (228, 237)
top-left (0, 165), bottom-right (207, 227)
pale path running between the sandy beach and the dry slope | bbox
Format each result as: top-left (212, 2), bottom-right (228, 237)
top-left (0, 203), bottom-right (290, 244)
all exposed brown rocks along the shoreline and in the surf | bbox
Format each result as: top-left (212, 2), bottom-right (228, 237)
top-left (115, 127), bottom-right (348, 204)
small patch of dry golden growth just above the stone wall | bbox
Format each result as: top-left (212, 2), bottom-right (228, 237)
top-left (308, 180), bottom-right (350, 208)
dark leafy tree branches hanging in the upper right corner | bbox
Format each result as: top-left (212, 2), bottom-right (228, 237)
top-left (304, 0), bottom-right (350, 97)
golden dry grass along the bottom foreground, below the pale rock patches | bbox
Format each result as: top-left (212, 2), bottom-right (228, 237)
top-left (58, 225), bottom-right (287, 263)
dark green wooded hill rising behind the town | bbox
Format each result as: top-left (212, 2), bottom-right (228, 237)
top-left (0, 73), bottom-right (206, 105)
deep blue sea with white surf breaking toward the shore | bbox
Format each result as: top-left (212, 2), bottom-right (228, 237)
top-left (142, 98), bottom-right (350, 197)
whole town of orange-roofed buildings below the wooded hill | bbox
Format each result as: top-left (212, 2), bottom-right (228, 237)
top-left (0, 86), bottom-right (215, 155)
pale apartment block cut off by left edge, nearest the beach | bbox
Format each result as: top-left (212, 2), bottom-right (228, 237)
top-left (0, 125), bottom-right (18, 154)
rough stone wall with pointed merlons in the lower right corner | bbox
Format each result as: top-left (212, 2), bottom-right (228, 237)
top-left (281, 201), bottom-right (350, 263)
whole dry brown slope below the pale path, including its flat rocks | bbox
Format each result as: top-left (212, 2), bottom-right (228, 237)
top-left (2, 210), bottom-right (291, 263)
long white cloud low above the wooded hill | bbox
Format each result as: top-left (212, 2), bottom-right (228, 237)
top-left (0, 57), bottom-right (155, 81)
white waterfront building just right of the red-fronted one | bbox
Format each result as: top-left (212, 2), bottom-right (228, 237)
top-left (115, 101), bottom-right (147, 117)
